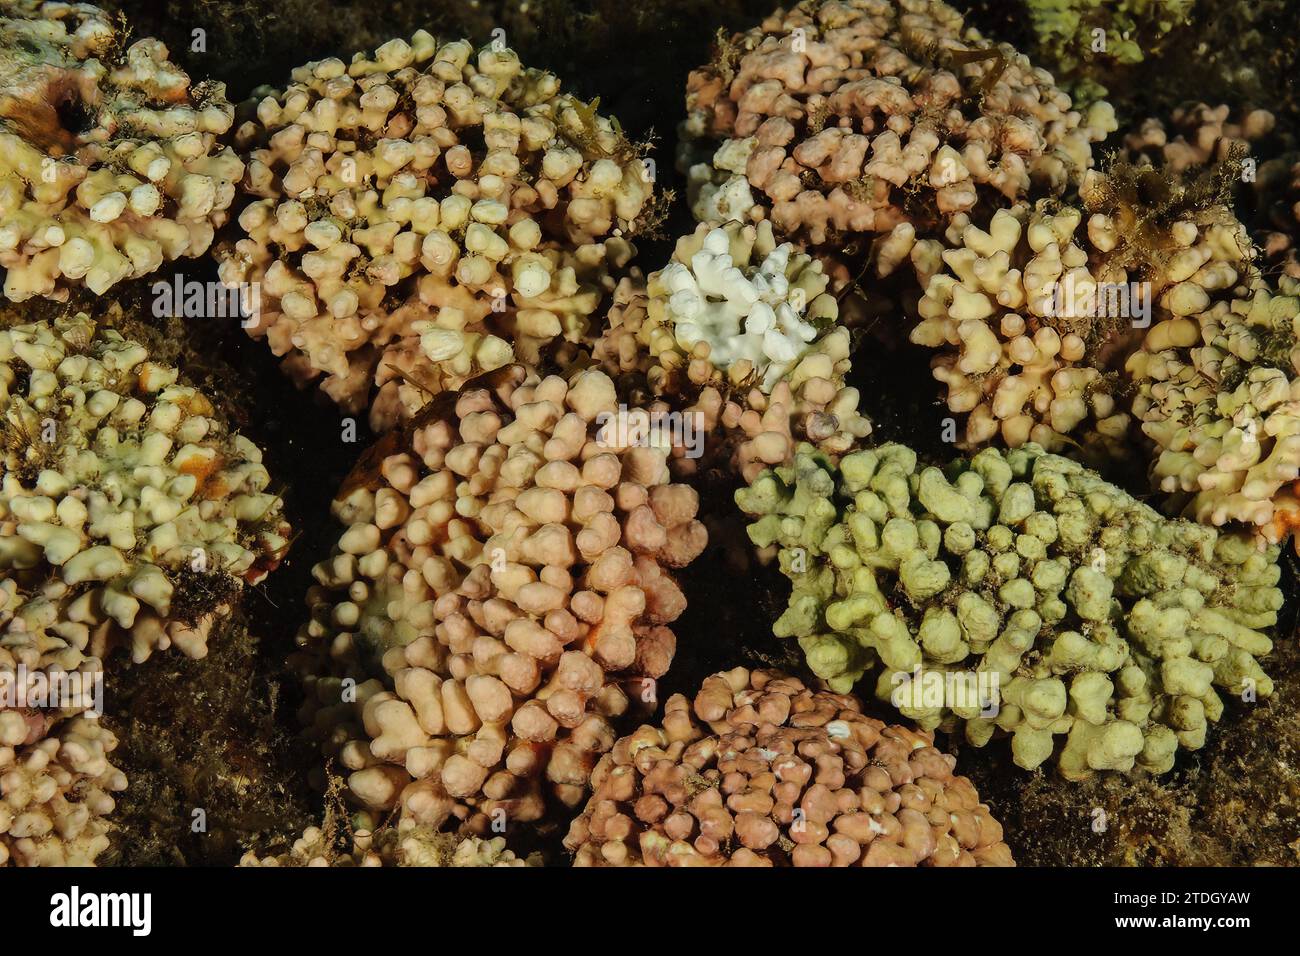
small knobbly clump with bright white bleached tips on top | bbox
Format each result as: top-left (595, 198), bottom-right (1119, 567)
top-left (594, 221), bottom-right (871, 480)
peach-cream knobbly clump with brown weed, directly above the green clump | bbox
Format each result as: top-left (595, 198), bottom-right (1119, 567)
top-left (904, 172), bottom-right (1249, 459)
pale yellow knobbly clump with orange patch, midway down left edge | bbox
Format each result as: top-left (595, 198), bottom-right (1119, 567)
top-left (0, 315), bottom-right (289, 661)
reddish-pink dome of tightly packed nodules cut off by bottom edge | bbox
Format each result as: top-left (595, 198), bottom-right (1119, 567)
top-left (566, 667), bottom-right (1013, 866)
